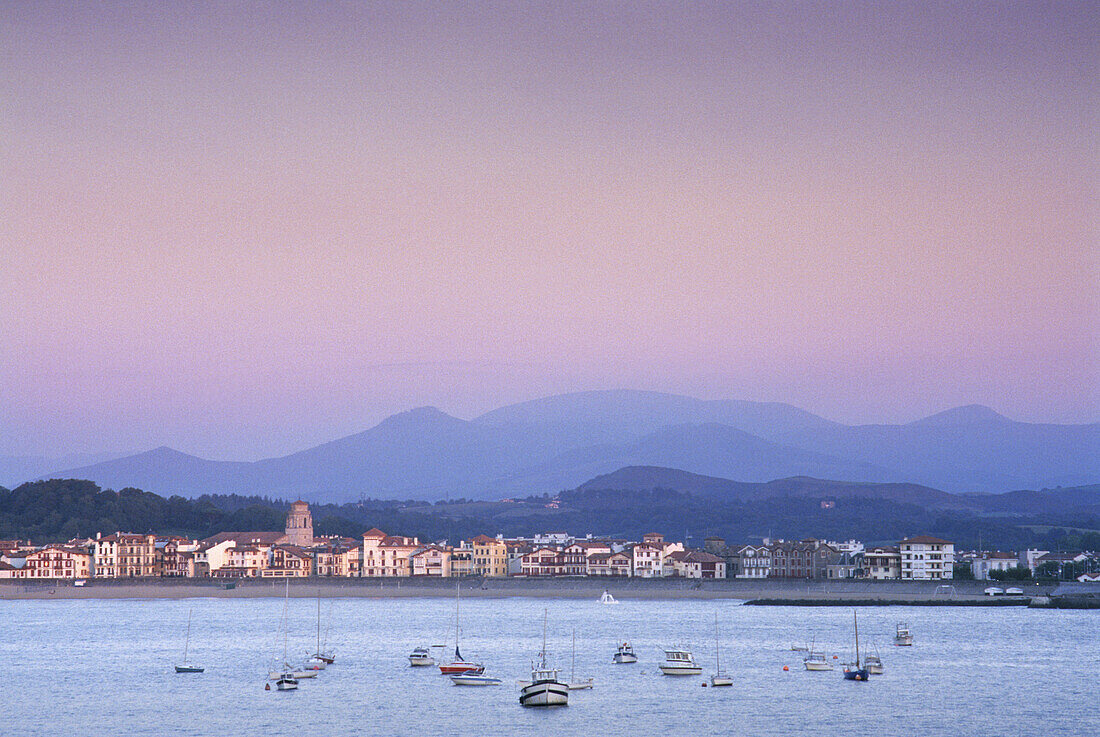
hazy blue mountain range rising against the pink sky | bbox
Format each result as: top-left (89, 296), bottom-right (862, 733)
top-left (17, 391), bottom-right (1100, 503)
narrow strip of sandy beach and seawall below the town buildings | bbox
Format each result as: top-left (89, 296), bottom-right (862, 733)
top-left (0, 579), bottom-right (1052, 605)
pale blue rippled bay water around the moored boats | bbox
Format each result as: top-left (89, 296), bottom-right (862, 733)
top-left (0, 597), bottom-right (1100, 737)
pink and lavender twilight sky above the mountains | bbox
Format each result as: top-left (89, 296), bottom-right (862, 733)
top-left (0, 2), bottom-right (1100, 460)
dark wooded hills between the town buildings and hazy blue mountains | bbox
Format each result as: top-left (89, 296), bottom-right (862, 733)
top-left (0, 480), bottom-right (1100, 550)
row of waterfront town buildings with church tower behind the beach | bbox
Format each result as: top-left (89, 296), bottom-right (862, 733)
top-left (0, 502), bottom-right (1100, 581)
